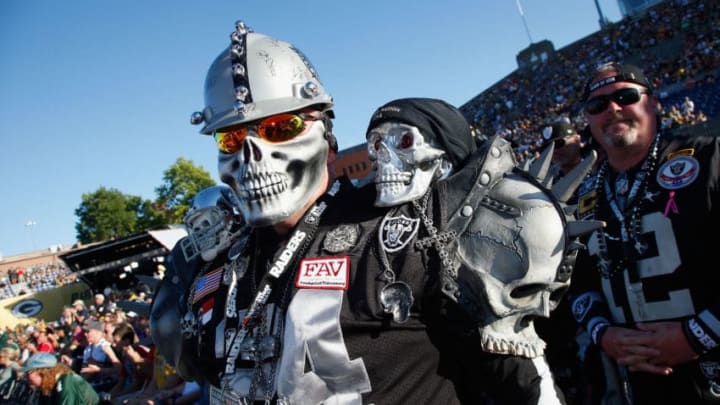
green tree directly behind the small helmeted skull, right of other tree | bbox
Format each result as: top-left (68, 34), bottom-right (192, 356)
top-left (155, 157), bottom-right (215, 224)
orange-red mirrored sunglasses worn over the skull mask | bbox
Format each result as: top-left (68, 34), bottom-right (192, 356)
top-left (213, 113), bottom-right (319, 154)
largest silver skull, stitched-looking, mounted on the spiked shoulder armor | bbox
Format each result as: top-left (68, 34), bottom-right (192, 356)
top-left (458, 173), bottom-right (570, 358)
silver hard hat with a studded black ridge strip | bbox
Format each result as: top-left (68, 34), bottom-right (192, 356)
top-left (190, 21), bottom-right (333, 135)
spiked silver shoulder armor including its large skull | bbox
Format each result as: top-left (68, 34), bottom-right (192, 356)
top-left (443, 136), bottom-right (597, 358)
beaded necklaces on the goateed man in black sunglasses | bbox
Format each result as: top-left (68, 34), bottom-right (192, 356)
top-left (593, 133), bottom-right (660, 278)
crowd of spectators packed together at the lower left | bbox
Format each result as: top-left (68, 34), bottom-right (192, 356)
top-left (0, 289), bottom-right (200, 404)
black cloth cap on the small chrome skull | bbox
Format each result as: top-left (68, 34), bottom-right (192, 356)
top-left (365, 98), bottom-right (477, 168)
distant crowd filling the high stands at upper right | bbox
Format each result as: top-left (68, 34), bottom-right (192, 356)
top-left (461, 0), bottom-right (720, 160)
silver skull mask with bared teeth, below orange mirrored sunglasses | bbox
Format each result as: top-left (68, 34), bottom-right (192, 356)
top-left (218, 120), bottom-right (329, 227)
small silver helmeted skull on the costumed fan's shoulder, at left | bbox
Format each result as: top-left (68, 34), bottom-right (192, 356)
top-left (180, 186), bottom-right (243, 261)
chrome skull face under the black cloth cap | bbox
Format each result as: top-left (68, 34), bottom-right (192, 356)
top-left (367, 121), bottom-right (452, 207)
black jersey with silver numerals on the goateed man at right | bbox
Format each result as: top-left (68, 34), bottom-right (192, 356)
top-left (570, 132), bottom-right (720, 400)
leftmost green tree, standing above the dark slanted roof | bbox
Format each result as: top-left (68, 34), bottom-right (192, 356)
top-left (75, 187), bottom-right (146, 243)
